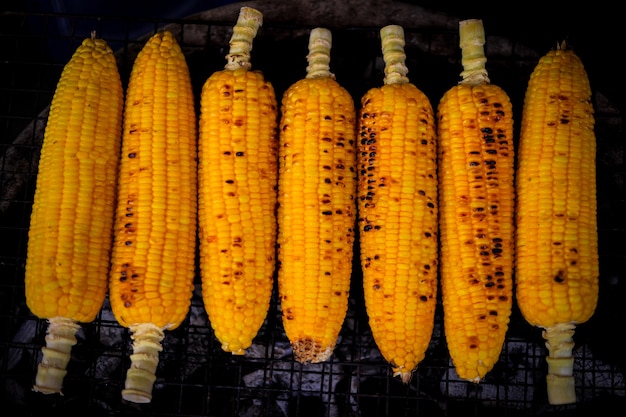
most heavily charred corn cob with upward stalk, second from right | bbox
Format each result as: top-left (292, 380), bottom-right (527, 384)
top-left (437, 19), bottom-right (514, 383)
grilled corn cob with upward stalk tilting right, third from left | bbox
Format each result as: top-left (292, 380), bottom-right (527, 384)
top-left (198, 7), bottom-right (278, 354)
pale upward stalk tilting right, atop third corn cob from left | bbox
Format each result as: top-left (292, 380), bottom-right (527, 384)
top-left (224, 6), bottom-right (263, 70)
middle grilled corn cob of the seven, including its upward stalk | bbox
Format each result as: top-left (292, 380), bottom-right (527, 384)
top-left (278, 28), bottom-right (356, 363)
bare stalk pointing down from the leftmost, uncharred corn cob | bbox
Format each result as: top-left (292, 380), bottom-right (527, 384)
top-left (33, 317), bottom-right (80, 395)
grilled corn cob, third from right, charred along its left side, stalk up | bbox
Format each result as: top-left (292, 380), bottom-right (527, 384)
top-left (358, 25), bottom-right (438, 383)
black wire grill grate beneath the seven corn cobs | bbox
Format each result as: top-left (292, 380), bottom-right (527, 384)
top-left (0, 9), bottom-right (626, 417)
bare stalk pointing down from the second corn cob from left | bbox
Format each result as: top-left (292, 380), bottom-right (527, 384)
top-left (122, 323), bottom-right (165, 403)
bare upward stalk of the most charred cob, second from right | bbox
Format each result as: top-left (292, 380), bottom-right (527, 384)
top-left (459, 19), bottom-right (490, 85)
